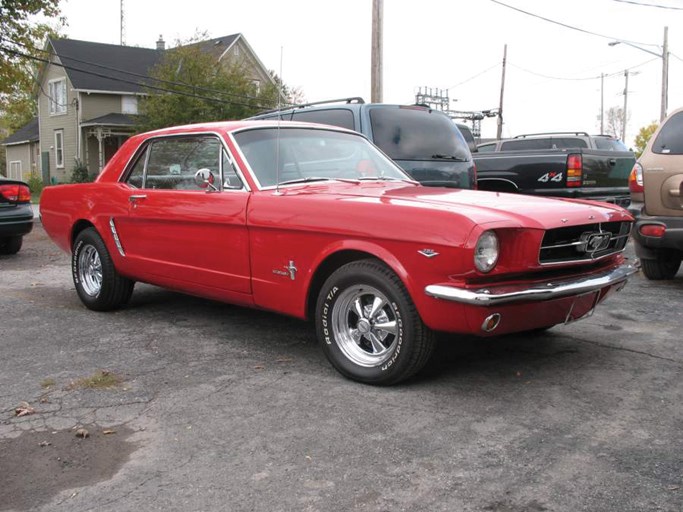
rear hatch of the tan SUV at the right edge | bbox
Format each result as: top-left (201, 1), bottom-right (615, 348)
top-left (640, 110), bottom-right (683, 217)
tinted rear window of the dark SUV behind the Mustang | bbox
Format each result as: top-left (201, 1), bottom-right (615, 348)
top-left (370, 107), bottom-right (471, 161)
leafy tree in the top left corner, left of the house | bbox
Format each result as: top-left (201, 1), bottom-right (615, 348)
top-left (0, 0), bottom-right (65, 132)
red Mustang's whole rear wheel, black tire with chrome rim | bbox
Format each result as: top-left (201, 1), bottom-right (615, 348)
top-left (71, 228), bottom-right (135, 311)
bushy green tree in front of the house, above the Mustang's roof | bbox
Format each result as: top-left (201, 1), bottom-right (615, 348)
top-left (136, 39), bottom-right (300, 132)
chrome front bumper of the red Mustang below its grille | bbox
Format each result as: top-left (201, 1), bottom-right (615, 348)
top-left (425, 264), bottom-right (639, 306)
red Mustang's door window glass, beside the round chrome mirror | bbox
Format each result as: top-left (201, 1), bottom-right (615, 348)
top-left (144, 136), bottom-right (222, 191)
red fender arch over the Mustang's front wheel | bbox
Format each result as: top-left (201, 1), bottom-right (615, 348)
top-left (304, 244), bottom-right (411, 319)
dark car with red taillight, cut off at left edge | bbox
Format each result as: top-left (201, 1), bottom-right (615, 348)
top-left (0, 177), bottom-right (33, 254)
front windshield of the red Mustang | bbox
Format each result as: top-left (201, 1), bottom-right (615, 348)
top-left (234, 127), bottom-right (410, 188)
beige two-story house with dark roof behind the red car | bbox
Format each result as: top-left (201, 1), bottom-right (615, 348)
top-left (1, 34), bottom-right (273, 184)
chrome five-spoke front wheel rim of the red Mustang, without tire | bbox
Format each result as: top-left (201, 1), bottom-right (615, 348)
top-left (331, 285), bottom-right (400, 367)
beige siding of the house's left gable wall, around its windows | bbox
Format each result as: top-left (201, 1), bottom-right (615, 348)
top-left (38, 55), bottom-right (78, 182)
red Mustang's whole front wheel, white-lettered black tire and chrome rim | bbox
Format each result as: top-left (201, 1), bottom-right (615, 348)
top-left (316, 259), bottom-right (435, 385)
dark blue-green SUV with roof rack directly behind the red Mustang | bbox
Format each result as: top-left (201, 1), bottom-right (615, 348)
top-left (250, 98), bottom-right (477, 189)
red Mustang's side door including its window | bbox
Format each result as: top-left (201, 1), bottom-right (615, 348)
top-left (117, 134), bottom-right (251, 293)
